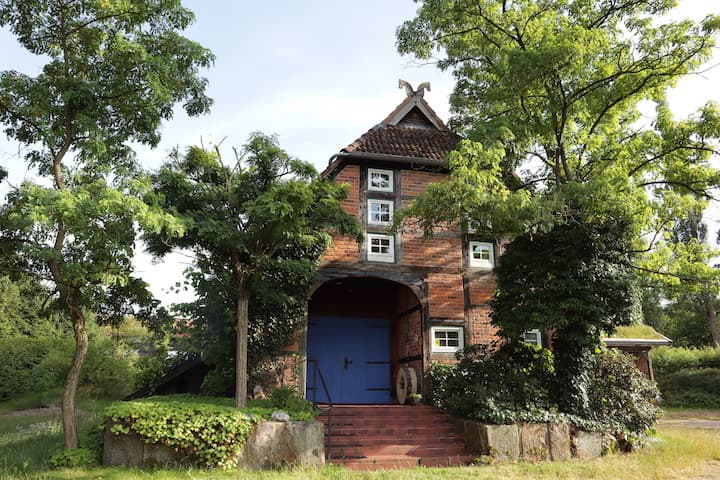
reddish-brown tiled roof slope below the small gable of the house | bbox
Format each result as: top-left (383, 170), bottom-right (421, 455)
top-left (342, 123), bottom-right (460, 160)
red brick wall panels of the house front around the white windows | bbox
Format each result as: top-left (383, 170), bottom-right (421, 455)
top-left (323, 165), bottom-right (496, 361)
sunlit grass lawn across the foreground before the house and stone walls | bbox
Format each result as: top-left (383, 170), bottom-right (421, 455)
top-left (0, 400), bottom-right (720, 480)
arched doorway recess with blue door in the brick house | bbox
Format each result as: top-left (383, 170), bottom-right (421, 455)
top-left (306, 277), bottom-right (423, 403)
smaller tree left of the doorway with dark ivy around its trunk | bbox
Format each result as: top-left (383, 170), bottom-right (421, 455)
top-left (148, 132), bottom-right (361, 407)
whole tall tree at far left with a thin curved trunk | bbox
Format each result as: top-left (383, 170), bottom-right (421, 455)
top-left (0, 0), bottom-right (213, 448)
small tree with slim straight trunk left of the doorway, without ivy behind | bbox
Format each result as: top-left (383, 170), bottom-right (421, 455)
top-left (149, 133), bottom-right (361, 407)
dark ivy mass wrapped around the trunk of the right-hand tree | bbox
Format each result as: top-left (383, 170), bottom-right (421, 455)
top-left (491, 222), bottom-right (639, 416)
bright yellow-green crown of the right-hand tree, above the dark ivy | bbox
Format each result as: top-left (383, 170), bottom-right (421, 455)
top-left (397, 0), bottom-right (720, 412)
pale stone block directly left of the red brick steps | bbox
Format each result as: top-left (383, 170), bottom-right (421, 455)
top-left (238, 422), bottom-right (325, 470)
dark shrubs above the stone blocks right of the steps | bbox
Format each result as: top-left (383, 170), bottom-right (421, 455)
top-left (431, 344), bottom-right (659, 440)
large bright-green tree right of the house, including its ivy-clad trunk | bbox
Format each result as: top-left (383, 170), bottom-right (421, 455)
top-left (397, 0), bottom-right (720, 414)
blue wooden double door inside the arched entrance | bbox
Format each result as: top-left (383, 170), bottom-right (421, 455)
top-left (306, 316), bottom-right (391, 403)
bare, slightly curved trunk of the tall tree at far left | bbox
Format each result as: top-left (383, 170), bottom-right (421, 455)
top-left (60, 297), bottom-right (88, 448)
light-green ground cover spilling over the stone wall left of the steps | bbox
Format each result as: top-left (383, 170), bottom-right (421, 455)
top-left (105, 389), bottom-right (317, 468)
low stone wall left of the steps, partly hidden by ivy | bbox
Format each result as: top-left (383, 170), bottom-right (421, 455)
top-left (103, 422), bottom-right (325, 470)
